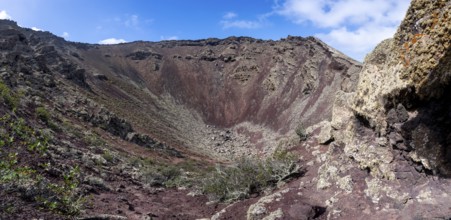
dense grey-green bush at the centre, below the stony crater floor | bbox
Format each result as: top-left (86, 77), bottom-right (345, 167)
top-left (202, 151), bottom-right (301, 201)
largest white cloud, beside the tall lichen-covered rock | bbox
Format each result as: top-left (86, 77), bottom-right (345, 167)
top-left (276, 0), bottom-right (410, 60)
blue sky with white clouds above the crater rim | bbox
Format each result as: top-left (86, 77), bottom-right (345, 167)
top-left (0, 0), bottom-right (410, 61)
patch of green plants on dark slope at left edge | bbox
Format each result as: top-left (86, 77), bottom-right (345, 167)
top-left (0, 115), bottom-right (84, 215)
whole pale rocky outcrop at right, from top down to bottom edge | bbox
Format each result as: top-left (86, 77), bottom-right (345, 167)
top-left (309, 0), bottom-right (451, 219)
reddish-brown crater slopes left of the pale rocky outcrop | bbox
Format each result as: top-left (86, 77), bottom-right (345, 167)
top-left (0, 18), bottom-right (361, 219)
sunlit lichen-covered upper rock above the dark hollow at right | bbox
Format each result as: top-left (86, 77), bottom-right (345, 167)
top-left (352, 0), bottom-right (451, 133)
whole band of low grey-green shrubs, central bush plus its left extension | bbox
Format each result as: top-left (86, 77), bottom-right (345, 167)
top-left (130, 150), bottom-right (302, 202)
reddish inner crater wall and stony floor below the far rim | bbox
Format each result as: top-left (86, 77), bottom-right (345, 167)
top-left (69, 34), bottom-right (360, 158)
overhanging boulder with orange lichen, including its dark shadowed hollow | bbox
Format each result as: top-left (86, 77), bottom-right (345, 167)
top-left (352, 1), bottom-right (451, 176)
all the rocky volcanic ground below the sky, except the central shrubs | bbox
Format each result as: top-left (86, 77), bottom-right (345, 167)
top-left (0, 0), bottom-right (451, 219)
